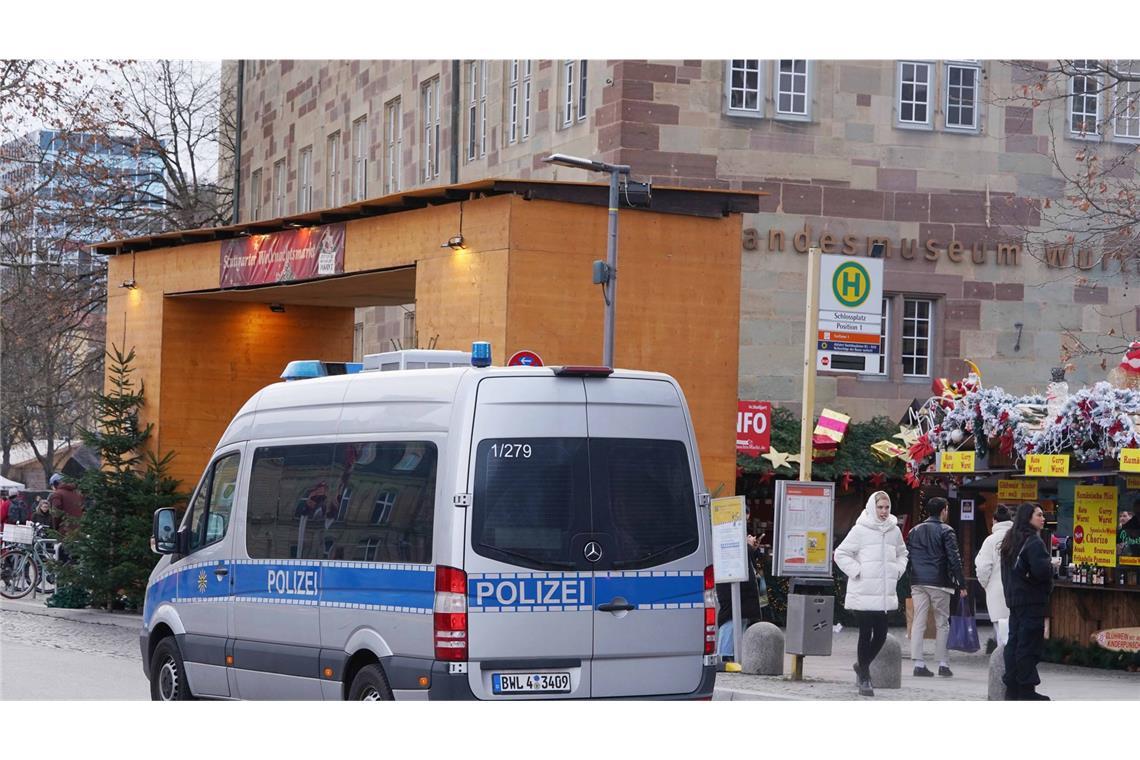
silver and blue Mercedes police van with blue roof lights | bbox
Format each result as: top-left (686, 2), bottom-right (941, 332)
top-left (140, 344), bottom-right (716, 701)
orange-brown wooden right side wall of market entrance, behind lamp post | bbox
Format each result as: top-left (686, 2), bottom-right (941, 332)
top-left (506, 197), bottom-right (742, 496)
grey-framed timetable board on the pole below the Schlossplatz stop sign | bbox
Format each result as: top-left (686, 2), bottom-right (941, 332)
top-left (772, 481), bottom-right (836, 578)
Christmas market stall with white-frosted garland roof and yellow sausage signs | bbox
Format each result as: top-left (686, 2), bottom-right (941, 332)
top-left (898, 353), bottom-right (1140, 662)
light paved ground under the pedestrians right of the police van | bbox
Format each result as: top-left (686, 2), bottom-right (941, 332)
top-left (714, 624), bottom-right (1140, 701)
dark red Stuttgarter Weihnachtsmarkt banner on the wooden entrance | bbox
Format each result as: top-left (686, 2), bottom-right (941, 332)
top-left (220, 224), bottom-right (344, 287)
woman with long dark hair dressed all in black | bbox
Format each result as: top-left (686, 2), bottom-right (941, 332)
top-left (1001, 504), bottom-right (1053, 700)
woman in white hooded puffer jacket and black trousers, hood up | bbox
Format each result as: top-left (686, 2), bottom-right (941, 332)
top-left (834, 491), bottom-right (906, 696)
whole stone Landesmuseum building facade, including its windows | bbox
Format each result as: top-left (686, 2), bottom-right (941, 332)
top-left (226, 59), bottom-right (1140, 428)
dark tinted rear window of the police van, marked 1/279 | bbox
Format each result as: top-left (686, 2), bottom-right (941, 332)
top-left (471, 438), bottom-right (700, 570)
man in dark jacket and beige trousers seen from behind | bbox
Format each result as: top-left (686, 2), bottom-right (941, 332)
top-left (906, 497), bottom-right (966, 677)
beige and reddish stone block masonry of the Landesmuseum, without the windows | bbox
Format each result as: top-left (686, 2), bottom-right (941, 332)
top-left (227, 60), bottom-right (1140, 428)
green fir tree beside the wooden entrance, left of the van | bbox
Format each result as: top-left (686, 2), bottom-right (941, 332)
top-left (60, 345), bottom-right (184, 610)
